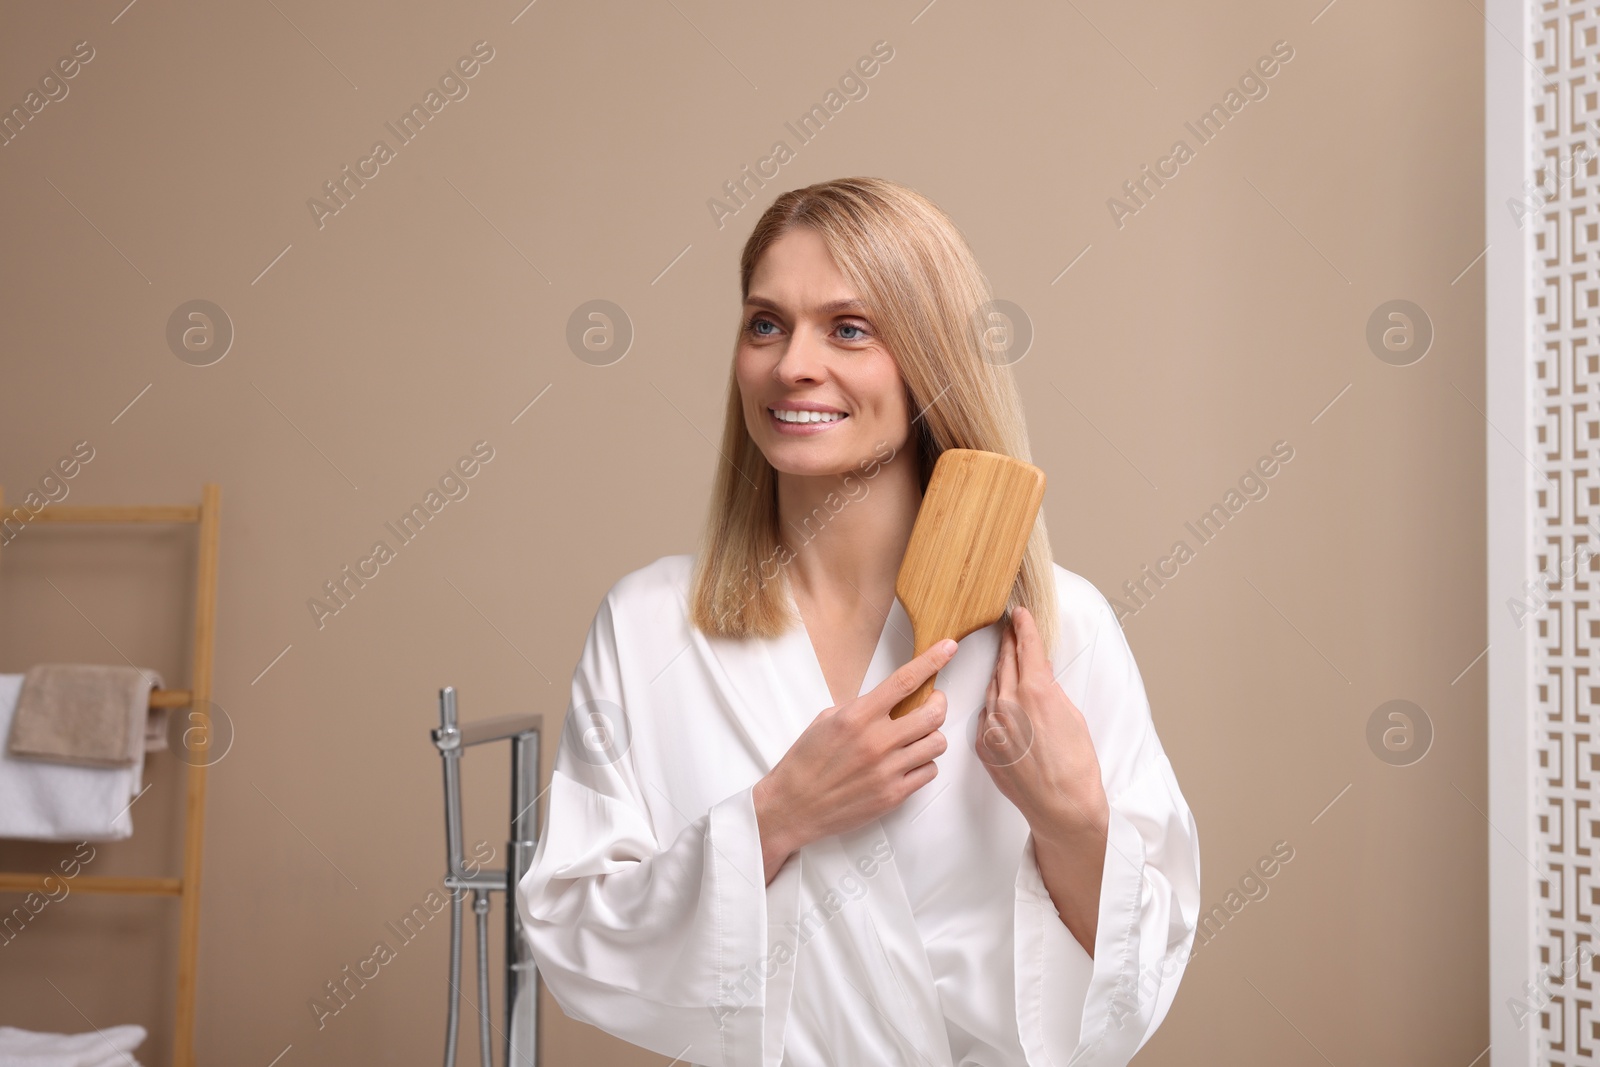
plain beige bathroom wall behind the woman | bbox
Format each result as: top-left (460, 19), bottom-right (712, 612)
top-left (0, 0), bottom-right (1493, 1067)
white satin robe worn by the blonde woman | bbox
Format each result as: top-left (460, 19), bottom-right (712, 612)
top-left (517, 555), bottom-right (1200, 1067)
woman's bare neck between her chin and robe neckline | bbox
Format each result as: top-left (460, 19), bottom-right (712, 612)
top-left (778, 450), bottom-right (922, 614)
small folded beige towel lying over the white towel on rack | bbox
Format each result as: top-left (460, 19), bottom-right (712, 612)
top-left (6, 664), bottom-right (165, 766)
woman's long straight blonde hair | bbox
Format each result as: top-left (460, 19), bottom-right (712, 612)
top-left (690, 178), bottom-right (1059, 656)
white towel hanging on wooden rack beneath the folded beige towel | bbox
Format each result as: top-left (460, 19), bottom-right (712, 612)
top-left (0, 673), bottom-right (144, 844)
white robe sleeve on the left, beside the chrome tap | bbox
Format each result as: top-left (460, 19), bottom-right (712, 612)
top-left (517, 589), bottom-right (802, 1067)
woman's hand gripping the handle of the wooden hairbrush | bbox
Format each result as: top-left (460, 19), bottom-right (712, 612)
top-left (752, 638), bottom-right (955, 881)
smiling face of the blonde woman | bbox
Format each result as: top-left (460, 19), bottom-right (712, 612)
top-left (734, 226), bottom-right (910, 475)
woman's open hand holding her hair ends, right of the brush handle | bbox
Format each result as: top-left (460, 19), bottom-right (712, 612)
top-left (976, 608), bottom-right (1109, 841)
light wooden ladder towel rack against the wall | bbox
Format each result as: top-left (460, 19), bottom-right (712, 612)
top-left (0, 482), bottom-right (222, 1067)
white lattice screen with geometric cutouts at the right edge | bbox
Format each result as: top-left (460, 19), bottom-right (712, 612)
top-left (1526, 0), bottom-right (1600, 1065)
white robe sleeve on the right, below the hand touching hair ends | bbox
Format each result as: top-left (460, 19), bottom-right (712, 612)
top-left (1014, 590), bottom-right (1200, 1067)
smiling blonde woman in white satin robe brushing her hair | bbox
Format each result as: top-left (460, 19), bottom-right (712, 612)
top-left (518, 178), bottom-right (1200, 1067)
